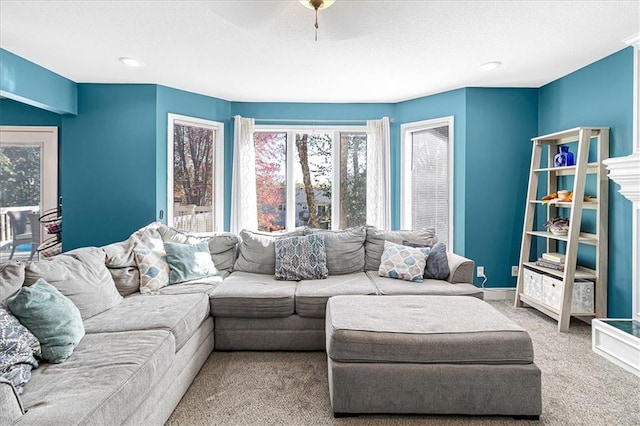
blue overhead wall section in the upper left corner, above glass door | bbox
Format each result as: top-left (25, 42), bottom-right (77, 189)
top-left (0, 49), bottom-right (78, 114)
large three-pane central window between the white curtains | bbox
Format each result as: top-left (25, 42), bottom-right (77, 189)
top-left (254, 126), bottom-right (367, 231)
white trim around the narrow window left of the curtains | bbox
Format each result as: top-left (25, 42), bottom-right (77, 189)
top-left (167, 113), bottom-right (224, 232)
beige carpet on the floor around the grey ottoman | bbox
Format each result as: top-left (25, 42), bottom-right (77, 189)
top-left (167, 301), bottom-right (640, 426)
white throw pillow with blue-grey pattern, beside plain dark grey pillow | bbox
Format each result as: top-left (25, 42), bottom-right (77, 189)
top-left (378, 241), bottom-right (429, 283)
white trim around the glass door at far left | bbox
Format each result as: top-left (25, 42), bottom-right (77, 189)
top-left (0, 126), bottom-right (58, 214)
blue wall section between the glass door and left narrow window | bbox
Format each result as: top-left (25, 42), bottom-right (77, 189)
top-left (60, 84), bottom-right (156, 251)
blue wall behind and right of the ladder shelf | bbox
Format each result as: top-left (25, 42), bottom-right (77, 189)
top-left (538, 47), bottom-right (633, 318)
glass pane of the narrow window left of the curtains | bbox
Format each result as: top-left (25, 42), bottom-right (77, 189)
top-left (173, 123), bottom-right (215, 232)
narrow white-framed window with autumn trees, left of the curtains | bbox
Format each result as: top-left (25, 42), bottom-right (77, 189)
top-left (167, 114), bottom-right (224, 234)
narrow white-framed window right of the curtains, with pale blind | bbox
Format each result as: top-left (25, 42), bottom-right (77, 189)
top-left (400, 117), bottom-right (453, 248)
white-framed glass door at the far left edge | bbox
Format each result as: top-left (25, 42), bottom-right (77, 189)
top-left (0, 126), bottom-right (58, 262)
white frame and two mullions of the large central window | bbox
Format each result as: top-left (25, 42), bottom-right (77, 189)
top-left (253, 124), bottom-right (370, 231)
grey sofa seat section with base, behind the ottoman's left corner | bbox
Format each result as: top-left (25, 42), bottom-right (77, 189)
top-left (296, 272), bottom-right (376, 318)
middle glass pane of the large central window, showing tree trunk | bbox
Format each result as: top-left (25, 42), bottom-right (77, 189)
top-left (294, 133), bottom-right (333, 229)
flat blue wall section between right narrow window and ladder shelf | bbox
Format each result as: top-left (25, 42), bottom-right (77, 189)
top-left (464, 88), bottom-right (538, 287)
